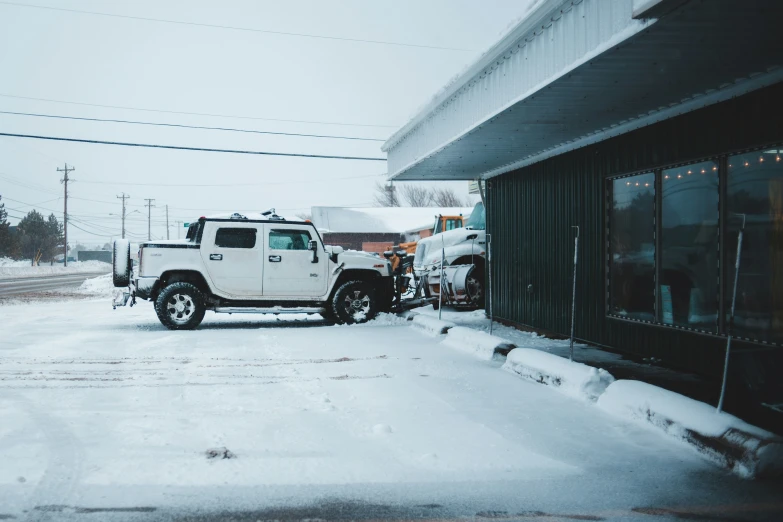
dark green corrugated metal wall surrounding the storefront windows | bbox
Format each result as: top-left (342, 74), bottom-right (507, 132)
top-left (487, 84), bottom-right (783, 375)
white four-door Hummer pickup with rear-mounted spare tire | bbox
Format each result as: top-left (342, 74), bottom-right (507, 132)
top-left (113, 209), bottom-right (393, 330)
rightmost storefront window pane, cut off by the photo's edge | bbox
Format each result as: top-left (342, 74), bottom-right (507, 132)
top-left (724, 148), bottom-right (783, 342)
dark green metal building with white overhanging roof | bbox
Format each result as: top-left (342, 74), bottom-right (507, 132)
top-left (384, 0), bottom-right (783, 420)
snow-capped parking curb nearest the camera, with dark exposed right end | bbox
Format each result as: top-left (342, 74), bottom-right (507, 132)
top-left (598, 380), bottom-right (783, 478)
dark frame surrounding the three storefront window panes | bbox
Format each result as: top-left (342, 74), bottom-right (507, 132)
top-left (604, 141), bottom-right (783, 346)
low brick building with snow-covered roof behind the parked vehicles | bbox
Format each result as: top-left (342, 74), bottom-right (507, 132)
top-left (312, 207), bottom-right (472, 252)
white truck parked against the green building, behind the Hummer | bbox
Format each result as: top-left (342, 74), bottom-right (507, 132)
top-left (413, 203), bottom-right (487, 308)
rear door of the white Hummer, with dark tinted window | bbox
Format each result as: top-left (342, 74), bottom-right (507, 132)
top-left (201, 221), bottom-right (264, 298)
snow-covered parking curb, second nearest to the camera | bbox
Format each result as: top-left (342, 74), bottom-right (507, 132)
top-left (503, 348), bottom-right (614, 402)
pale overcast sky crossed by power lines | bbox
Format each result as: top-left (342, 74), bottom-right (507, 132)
top-left (0, 0), bottom-right (529, 244)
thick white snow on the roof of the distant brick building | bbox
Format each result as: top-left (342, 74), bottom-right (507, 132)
top-left (312, 207), bottom-right (473, 234)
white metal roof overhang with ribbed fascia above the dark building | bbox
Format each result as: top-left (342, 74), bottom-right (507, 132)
top-left (384, 0), bottom-right (783, 180)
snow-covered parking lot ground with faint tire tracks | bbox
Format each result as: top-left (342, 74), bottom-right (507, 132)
top-left (0, 282), bottom-right (783, 521)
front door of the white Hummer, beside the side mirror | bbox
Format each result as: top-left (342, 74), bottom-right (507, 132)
top-left (264, 223), bottom-right (329, 298)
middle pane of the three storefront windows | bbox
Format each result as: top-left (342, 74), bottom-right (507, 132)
top-left (658, 161), bottom-right (719, 332)
